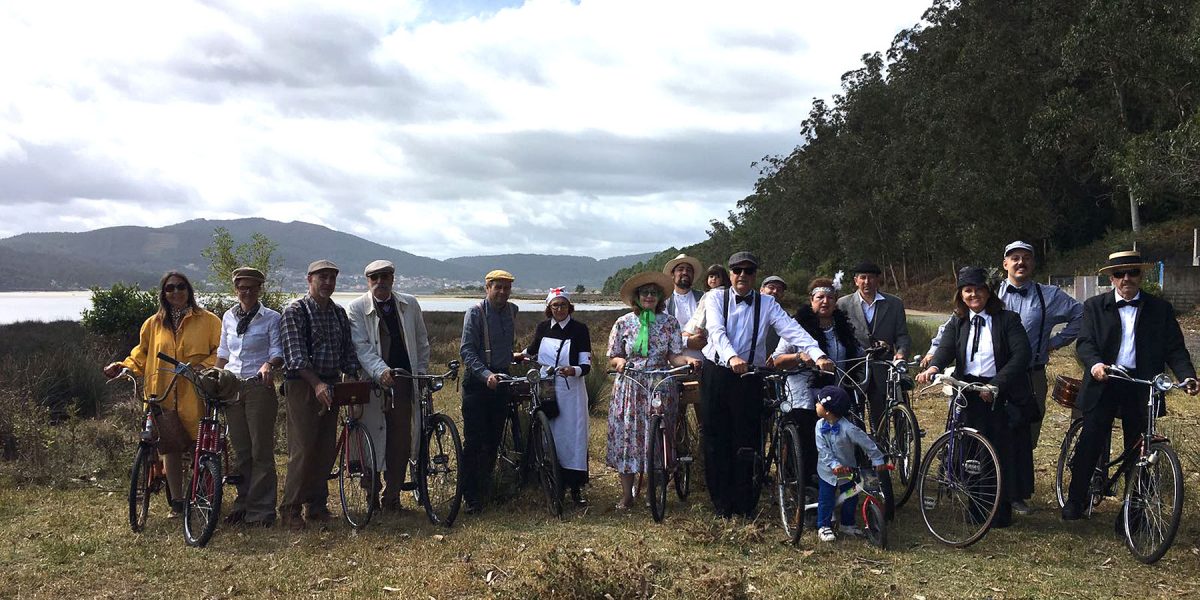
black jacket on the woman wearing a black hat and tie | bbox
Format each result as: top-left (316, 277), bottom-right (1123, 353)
top-left (932, 311), bottom-right (1036, 408)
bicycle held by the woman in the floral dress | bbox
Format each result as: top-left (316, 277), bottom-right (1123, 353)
top-left (608, 365), bottom-right (692, 523)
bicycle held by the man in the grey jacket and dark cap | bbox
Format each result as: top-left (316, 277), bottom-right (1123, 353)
top-left (839, 344), bottom-right (925, 514)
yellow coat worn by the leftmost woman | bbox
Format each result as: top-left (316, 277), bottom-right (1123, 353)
top-left (121, 308), bottom-right (221, 442)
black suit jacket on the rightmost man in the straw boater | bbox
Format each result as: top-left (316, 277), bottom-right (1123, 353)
top-left (1075, 292), bottom-right (1196, 412)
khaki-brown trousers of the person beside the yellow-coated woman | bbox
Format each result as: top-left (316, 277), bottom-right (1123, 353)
top-left (226, 380), bottom-right (280, 522)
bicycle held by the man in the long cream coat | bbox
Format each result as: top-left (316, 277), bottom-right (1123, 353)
top-left (391, 360), bottom-right (462, 527)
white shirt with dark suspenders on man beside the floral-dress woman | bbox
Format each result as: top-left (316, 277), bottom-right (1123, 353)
top-left (704, 289), bottom-right (826, 367)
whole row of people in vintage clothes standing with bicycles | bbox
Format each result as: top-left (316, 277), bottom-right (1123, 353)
top-left (104, 241), bottom-right (1200, 541)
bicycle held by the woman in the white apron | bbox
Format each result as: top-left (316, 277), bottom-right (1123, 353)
top-left (497, 360), bottom-right (563, 517)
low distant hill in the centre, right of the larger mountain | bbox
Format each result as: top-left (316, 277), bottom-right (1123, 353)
top-left (446, 252), bottom-right (654, 290)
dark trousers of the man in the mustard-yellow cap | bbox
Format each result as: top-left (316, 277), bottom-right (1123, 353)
top-left (462, 380), bottom-right (509, 503)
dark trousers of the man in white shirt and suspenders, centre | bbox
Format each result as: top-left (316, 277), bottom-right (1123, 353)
top-left (701, 361), bottom-right (762, 517)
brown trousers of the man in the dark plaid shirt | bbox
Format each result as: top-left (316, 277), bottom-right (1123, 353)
top-left (280, 379), bottom-right (337, 516)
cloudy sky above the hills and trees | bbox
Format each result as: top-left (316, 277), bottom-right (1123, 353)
top-left (0, 0), bottom-right (930, 258)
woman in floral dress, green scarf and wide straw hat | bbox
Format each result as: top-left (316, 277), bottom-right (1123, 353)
top-left (605, 271), bottom-right (700, 510)
